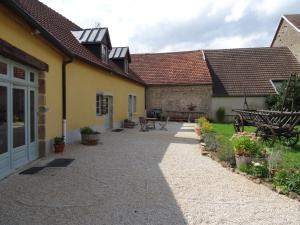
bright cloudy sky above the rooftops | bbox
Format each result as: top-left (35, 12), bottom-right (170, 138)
top-left (40, 0), bottom-right (300, 53)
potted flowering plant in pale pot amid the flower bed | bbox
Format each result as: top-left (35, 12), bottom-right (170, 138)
top-left (233, 136), bottom-right (260, 168)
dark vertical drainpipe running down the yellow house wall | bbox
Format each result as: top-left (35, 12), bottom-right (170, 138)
top-left (62, 59), bottom-right (73, 143)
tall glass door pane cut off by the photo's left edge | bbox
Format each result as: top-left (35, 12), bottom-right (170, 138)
top-left (0, 86), bottom-right (8, 155)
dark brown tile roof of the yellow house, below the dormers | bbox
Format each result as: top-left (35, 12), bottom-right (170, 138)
top-left (7, 0), bottom-right (143, 83)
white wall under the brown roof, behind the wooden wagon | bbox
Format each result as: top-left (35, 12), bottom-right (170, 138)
top-left (211, 97), bottom-right (266, 122)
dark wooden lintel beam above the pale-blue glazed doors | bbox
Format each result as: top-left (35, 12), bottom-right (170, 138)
top-left (0, 39), bottom-right (49, 72)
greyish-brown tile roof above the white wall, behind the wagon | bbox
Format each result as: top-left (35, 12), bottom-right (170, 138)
top-left (204, 47), bottom-right (300, 96)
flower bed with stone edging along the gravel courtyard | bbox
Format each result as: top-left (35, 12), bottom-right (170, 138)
top-left (197, 118), bottom-right (300, 201)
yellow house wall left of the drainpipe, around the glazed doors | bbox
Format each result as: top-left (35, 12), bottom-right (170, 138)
top-left (0, 4), bottom-right (63, 140)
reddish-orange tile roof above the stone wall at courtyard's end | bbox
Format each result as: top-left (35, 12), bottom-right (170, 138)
top-left (130, 51), bottom-right (212, 85)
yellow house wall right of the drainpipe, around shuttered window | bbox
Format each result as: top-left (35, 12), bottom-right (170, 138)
top-left (67, 60), bottom-right (145, 131)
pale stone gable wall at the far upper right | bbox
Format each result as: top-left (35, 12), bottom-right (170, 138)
top-left (272, 19), bottom-right (300, 62)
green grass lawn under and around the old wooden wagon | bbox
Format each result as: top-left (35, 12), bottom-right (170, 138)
top-left (213, 123), bottom-right (300, 169)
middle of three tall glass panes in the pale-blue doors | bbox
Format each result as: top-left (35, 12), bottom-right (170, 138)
top-left (13, 89), bottom-right (25, 148)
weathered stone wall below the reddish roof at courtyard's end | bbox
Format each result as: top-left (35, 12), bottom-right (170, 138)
top-left (146, 85), bottom-right (212, 118)
